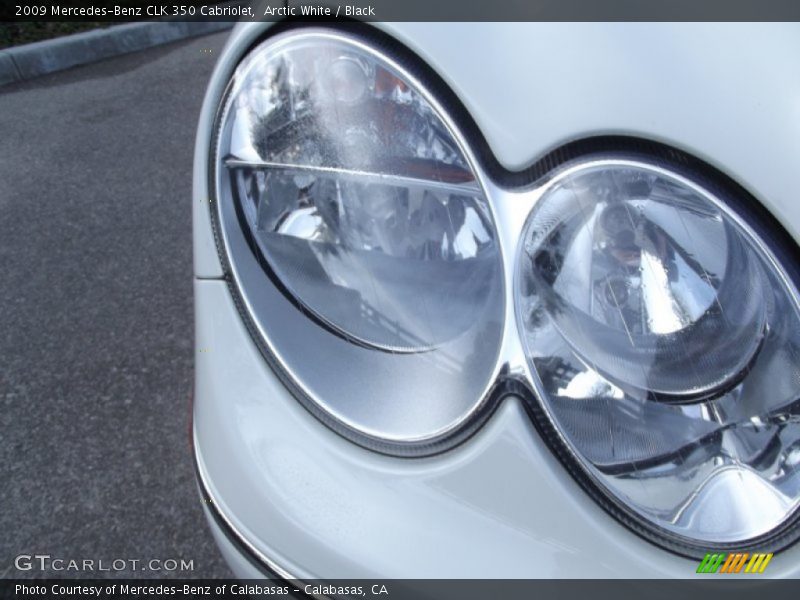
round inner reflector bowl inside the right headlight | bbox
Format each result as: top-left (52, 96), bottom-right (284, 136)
top-left (525, 168), bottom-right (767, 402)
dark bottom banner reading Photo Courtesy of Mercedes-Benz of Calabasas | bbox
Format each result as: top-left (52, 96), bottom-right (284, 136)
top-left (0, 580), bottom-right (800, 600)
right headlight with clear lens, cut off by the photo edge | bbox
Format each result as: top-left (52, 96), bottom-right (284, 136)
top-left (517, 161), bottom-right (800, 543)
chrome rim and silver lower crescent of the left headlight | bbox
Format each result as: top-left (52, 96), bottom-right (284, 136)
top-left (209, 28), bottom-right (506, 456)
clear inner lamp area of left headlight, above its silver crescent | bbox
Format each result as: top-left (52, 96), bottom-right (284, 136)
top-left (224, 38), bottom-right (499, 352)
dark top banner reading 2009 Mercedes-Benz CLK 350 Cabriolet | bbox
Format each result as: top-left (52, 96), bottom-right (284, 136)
top-left (0, 0), bottom-right (800, 23)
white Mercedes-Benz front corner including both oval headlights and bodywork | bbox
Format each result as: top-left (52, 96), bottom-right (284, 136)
top-left (193, 23), bottom-right (800, 579)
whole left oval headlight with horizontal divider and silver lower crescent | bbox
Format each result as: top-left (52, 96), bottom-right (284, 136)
top-left (209, 30), bottom-right (504, 444)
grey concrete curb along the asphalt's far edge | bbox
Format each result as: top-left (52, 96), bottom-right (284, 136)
top-left (0, 21), bottom-right (234, 86)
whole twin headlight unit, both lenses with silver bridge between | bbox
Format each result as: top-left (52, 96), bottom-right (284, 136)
top-left (210, 29), bottom-right (800, 554)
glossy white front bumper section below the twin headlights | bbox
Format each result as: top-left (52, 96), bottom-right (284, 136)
top-left (194, 281), bottom-right (800, 579)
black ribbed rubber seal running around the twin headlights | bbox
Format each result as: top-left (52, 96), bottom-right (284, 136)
top-left (209, 21), bottom-right (800, 558)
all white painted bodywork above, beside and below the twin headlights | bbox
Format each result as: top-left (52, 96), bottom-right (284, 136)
top-left (193, 23), bottom-right (800, 578)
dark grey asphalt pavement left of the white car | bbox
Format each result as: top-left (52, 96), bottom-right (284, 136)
top-left (0, 33), bottom-right (230, 578)
